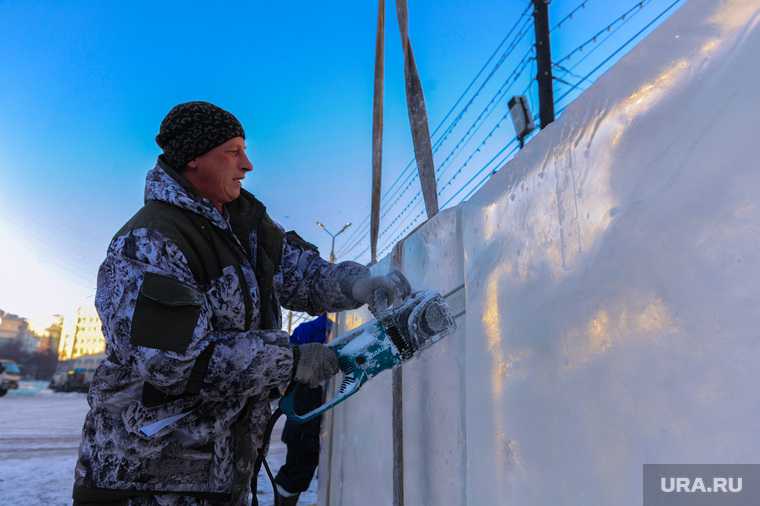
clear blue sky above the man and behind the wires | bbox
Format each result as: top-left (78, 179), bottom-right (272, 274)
top-left (0, 0), bottom-right (671, 324)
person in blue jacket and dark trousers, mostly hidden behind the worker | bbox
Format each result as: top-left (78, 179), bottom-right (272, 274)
top-left (275, 314), bottom-right (332, 506)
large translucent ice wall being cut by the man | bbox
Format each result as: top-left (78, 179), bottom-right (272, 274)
top-left (320, 0), bottom-right (760, 506)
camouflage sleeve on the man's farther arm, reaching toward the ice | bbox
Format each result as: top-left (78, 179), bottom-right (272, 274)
top-left (274, 228), bottom-right (369, 314)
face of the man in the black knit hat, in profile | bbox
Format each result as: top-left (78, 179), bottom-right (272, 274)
top-left (184, 137), bottom-right (253, 208)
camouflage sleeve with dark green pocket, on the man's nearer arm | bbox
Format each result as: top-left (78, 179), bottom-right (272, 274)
top-left (95, 229), bottom-right (293, 400)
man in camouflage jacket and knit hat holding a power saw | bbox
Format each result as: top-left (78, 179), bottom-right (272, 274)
top-left (74, 102), bottom-right (405, 505)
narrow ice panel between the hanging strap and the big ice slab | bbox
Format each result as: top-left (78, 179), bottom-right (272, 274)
top-left (394, 209), bottom-right (466, 506)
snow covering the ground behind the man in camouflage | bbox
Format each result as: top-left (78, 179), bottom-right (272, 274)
top-left (0, 382), bottom-right (317, 506)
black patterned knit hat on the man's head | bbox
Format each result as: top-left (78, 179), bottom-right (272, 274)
top-left (156, 102), bottom-right (245, 170)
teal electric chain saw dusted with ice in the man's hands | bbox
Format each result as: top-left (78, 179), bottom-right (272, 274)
top-left (280, 290), bottom-right (456, 423)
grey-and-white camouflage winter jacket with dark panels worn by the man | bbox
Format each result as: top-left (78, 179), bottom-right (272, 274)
top-left (74, 159), bottom-right (368, 504)
